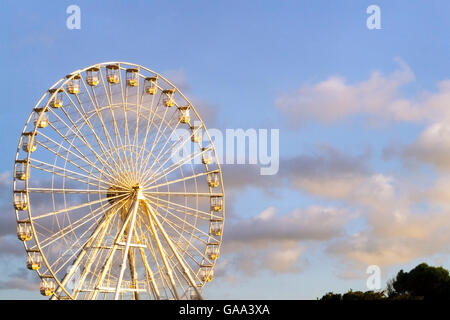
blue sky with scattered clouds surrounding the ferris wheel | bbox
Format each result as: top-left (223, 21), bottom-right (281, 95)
top-left (0, 0), bottom-right (450, 299)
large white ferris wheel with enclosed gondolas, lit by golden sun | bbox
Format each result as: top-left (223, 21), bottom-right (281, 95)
top-left (13, 62), bottom-right (225, 299)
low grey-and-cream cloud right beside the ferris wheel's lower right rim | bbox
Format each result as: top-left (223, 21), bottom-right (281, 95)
top-left (219, 206), bottom-right (355, 276)
